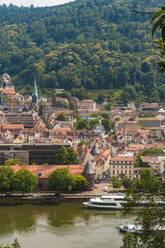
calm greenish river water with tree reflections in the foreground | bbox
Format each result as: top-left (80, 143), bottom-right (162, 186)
top-left (0, 203), bottom-right (132, 248)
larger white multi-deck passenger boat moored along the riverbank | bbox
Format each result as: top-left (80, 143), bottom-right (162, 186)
top-left (83, 195), bottom-right (125, 210)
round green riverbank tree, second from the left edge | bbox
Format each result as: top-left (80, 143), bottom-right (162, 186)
top-left (13, 169), bottom-right (38, 192)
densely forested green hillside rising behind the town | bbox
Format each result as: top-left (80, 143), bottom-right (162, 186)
top-left (0, 0), bottom-right (165, 101)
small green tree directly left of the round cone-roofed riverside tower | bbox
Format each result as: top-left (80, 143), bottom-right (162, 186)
top-left (72, 175), bottom-right (88, 192)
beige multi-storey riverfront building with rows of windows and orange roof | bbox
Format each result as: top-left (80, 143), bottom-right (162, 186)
top-left (109, 156), bottom-right (134, 179)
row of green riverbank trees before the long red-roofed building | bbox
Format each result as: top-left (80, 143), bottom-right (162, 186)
top-left (0, 166), bottom-right (88, 193)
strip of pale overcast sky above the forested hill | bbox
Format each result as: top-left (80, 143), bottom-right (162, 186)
top-left (0, 0), bottom-right (74, 6)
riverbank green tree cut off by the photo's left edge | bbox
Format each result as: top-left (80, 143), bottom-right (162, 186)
top-left (0, 166), bottom-right (14, 193)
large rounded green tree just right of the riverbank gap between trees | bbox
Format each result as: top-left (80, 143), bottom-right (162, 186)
top-left (48, 168), bottom-right (74, 192)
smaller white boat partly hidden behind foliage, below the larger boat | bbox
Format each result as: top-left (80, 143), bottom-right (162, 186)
top-left (119, 224), bottom-right (165, 234)
